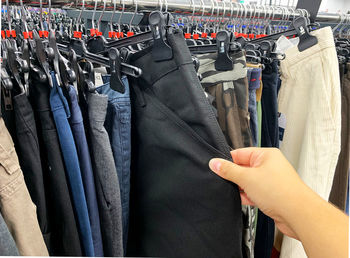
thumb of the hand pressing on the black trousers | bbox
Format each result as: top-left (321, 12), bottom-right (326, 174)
top-left (209, 159), bottom-right (247, 185)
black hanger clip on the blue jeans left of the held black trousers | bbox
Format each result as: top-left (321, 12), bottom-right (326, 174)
top-left (108, 48), bottom-right (125, 93)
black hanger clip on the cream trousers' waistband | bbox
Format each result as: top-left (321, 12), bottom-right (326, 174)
top-left (293, 16), bottom-right (318, 52)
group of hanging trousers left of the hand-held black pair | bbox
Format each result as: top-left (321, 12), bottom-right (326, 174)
top-left (0, 67), bottom-right (131, 256)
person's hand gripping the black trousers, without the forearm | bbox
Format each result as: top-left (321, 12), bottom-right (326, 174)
top-left (209, 148), bottom-right (309, 239)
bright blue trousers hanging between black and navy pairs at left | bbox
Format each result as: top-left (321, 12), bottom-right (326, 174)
top-left (50, 72), bottom-right (95, 256)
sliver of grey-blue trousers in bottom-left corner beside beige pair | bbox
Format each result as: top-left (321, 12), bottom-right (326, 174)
top-left (0, 213), bottom-right (19, 256)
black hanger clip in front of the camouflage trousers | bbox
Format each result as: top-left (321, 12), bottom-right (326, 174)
top-left (215, 31), bottom-right (233, 71)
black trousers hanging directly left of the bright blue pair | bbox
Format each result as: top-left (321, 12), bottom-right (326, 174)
top-left (30, 78), bottom-right (82, 256)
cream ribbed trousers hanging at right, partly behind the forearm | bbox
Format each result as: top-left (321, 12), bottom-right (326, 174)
top-left (277, 27), bottom-right (341, 258)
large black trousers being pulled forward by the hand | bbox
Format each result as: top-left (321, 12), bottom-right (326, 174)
top-left (127, 29), bottom-right (243, 258)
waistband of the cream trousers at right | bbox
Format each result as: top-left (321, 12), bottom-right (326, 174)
top-left (281, 26), bottom-right (335, 67)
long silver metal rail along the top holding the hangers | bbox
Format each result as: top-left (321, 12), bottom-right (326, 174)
top-left (5, 0), bottom-right (350, 23)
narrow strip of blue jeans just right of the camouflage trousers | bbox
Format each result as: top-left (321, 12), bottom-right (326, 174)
top-left (247, 68), bottom-right (261, 147)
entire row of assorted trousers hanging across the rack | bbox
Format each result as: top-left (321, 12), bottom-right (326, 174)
top-left (0, 17), bottom-right (350, 258)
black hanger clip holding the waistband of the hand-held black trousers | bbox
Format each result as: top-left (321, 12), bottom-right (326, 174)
top-left (149, 11), bottom-right (173, 62)
